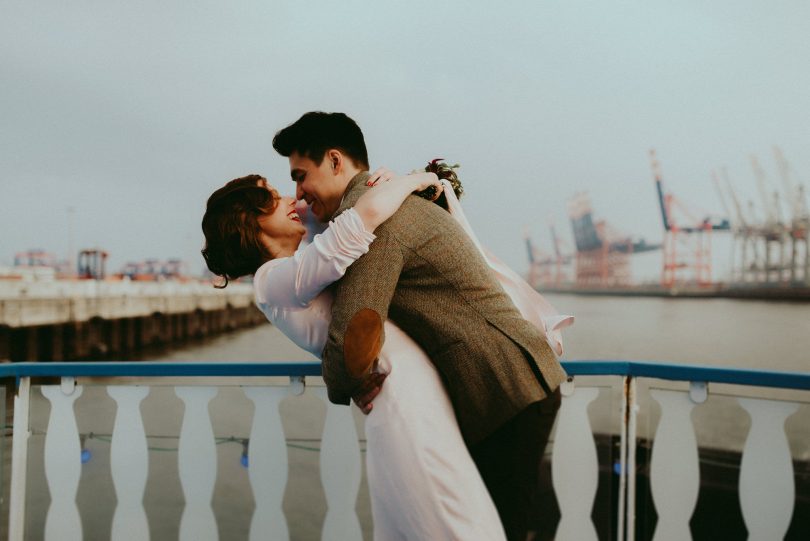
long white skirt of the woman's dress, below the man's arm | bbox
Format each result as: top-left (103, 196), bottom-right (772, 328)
top-left (366, 322), bottom-right (505, 541)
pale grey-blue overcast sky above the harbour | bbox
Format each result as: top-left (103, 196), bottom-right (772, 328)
top-left (0, 0), bottom-right (810, 278)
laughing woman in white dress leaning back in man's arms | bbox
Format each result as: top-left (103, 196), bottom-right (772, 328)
top-left (202, 169), bottom-right (570, 540)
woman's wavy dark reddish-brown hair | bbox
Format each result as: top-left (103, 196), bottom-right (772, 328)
top-left (202, 175), bottom-right (279, 289)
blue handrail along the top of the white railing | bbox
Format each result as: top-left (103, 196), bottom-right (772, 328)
top-left (0, 359), bottom-right (810, 390)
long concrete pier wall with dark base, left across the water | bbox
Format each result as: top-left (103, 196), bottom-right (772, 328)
top-left (0, 280), bottom-right (266, 362)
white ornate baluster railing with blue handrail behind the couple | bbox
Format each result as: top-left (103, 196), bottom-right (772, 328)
top-left (0, 361), bottom-right (810, 541)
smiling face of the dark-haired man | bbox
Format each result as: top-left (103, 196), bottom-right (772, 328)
top-left (290, 152), bottom-right (346, 222)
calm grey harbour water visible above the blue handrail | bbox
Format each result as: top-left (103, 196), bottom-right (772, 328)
top-left (146, 295), bottom-right (810, 372)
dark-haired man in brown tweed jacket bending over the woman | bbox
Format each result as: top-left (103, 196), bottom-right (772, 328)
top-left (273, 112), bottom-right (566, 541)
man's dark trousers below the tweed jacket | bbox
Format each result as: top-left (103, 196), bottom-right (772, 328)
top-left (470, 389), bottom-right (560, 541)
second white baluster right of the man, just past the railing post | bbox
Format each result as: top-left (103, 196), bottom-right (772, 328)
top-left (650, 390), bottom-right (700, 541)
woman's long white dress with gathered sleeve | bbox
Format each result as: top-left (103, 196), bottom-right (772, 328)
top-left (254, 182), bottom-right (570, 541)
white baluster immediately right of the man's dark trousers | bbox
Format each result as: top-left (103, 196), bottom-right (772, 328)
top-left (551, 382), bottom-right (599, 541)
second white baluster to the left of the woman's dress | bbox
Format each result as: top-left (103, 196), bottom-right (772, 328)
top-left (245, 387), bottom-right (290, 541)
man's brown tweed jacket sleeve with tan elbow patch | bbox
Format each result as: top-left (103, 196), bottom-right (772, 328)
top-left (322, 224), bottom-right (404, 404)
